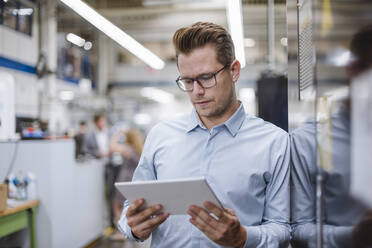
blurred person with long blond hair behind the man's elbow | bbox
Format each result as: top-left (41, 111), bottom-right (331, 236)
top-left (110, 128), bottom-right (144, 239)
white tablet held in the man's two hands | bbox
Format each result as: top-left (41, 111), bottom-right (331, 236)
top-left (115, 177), bottom-right (223, 215)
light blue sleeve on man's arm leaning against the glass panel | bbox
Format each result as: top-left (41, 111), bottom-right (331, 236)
top-left (244, 132), bottom-right (290, 248)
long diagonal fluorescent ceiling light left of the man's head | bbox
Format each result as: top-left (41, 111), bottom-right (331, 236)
top-left (60, 0), bottom-right (164, 70)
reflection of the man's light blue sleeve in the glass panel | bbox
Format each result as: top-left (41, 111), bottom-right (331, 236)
top-left (291, 123), bottom-right (352, 248)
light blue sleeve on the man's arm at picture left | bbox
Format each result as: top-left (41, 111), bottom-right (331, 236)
top-left (118, 126), bottom-right (157, 242)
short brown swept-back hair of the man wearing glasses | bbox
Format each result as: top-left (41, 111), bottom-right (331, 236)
top-left (173, 22), bottom-right (235, 65)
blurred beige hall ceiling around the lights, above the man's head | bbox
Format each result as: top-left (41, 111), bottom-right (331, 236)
top-left (57, 0), bottom-right (286, 68)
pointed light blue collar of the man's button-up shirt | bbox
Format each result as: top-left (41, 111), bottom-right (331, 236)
top-left (186, 103), bottom-right (245, 137)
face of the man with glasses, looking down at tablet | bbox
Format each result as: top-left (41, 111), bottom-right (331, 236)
top-left (178, 44), bottom-right (240, 119)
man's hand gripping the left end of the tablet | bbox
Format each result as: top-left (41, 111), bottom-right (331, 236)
top-left (126, 199), bottom-right (169, 240)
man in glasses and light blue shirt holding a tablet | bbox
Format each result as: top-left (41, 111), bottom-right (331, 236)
top-left (119, 22), bottom-right (289, 248)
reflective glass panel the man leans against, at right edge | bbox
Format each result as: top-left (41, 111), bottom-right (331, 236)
top-left (288, 0), bottom-right (372, 248)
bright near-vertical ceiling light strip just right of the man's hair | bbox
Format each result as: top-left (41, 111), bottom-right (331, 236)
top-left (226, 0), bottom-right (245, 68)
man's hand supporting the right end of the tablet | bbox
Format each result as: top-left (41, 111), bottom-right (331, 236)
top-left (187, 201), bottom-right (246, 247)
